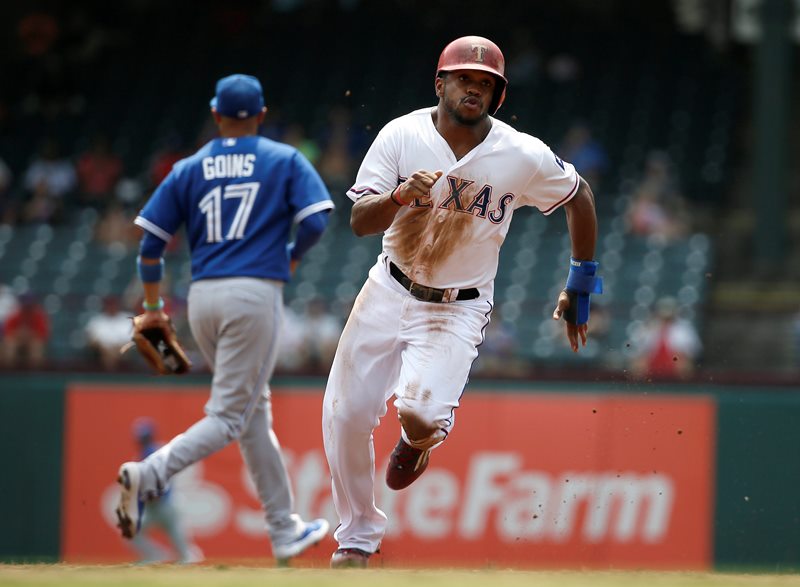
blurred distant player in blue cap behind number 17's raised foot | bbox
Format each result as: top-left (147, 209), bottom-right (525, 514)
top-left (128, 418), bottom-right (204, 564)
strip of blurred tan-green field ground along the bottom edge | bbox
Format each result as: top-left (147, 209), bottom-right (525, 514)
top-left (0, 564), bottom-right (800, 587)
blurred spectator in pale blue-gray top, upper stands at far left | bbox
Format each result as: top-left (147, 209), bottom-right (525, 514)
top-left (23, 139), bottom-right (77, 223)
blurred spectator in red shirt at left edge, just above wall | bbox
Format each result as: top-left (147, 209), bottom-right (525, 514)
top-left (3, 293), bottom-right (50, 367)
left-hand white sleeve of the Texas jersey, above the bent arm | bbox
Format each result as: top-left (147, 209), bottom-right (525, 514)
top-left (347, 123), bottom-right (401, 202)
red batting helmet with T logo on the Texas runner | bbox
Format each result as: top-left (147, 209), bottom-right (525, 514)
top-left (436, 36), bottom-right (508, 114)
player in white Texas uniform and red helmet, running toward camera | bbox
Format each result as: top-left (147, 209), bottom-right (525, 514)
top-left (323, 36), bottom-right (601, 567)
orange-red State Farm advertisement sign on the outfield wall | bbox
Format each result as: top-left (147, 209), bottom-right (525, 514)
top-left (62, 385), bottom-right (716, 569)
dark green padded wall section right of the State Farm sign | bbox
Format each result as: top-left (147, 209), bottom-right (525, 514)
top-left (715, 389), bottom-right (800, 570)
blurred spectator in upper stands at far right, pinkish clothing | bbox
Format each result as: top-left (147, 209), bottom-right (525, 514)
top-left (626, 151), bottom-right (689, 241)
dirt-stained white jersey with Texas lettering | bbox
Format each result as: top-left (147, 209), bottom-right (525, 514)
top-left (347, 108), bottom-right (579, 298)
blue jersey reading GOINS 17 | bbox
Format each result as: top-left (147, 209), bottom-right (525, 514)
top-left (135, 136), bottom-right (334, 281)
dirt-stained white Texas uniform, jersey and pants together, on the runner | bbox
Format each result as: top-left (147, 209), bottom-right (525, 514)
top-left (323, 108), bottom-right (580, 552)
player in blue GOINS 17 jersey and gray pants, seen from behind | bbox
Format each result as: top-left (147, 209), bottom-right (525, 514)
top-left (117, 75), bottom-right (334, 561)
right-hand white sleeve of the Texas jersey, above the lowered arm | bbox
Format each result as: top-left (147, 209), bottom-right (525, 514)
top-left (520, 142), bottom-right (580, 216)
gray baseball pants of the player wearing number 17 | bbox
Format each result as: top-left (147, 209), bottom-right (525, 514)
top-left (139, 277), bottom-right (302, 544)
